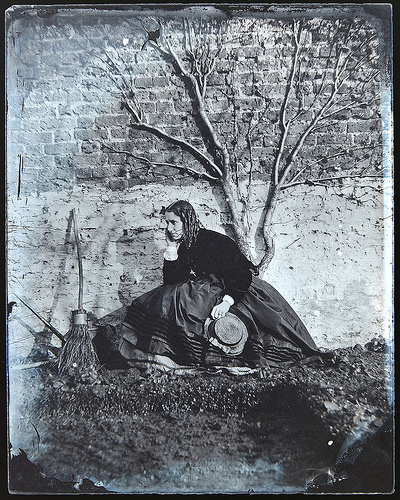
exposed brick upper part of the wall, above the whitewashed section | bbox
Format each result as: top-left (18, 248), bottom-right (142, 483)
top-left (7, 8), bottom-right (388, 195)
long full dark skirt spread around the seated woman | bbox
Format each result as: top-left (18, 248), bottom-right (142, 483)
top-left (119, 276), bottom-right (332, 368)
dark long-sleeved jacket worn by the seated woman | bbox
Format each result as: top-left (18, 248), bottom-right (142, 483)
top-left (163, 229), bottom-right (254, 302)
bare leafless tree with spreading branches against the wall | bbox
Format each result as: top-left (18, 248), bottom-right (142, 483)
top-left (80, 19), bottom-right (382, 272)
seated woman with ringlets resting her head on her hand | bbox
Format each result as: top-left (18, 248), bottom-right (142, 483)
top-left (119, 201), bottom-right (331, 368)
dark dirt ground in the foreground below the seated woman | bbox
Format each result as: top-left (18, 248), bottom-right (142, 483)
top-left (9, 339), bottom-right (393, 494)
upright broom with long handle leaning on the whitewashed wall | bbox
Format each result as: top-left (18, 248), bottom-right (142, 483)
top-left (57, 209), bottom-right (99, 375)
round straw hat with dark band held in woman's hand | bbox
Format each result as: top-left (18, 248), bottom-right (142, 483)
top-left (204, 312), bottom-right (248, 356)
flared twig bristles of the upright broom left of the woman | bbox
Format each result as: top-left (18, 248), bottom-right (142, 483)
top-left (58, 324), bottom-right (99, 374)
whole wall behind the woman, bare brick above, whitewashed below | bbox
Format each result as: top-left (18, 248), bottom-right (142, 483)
top-left (7, 7), bottom-right (392, 360)
